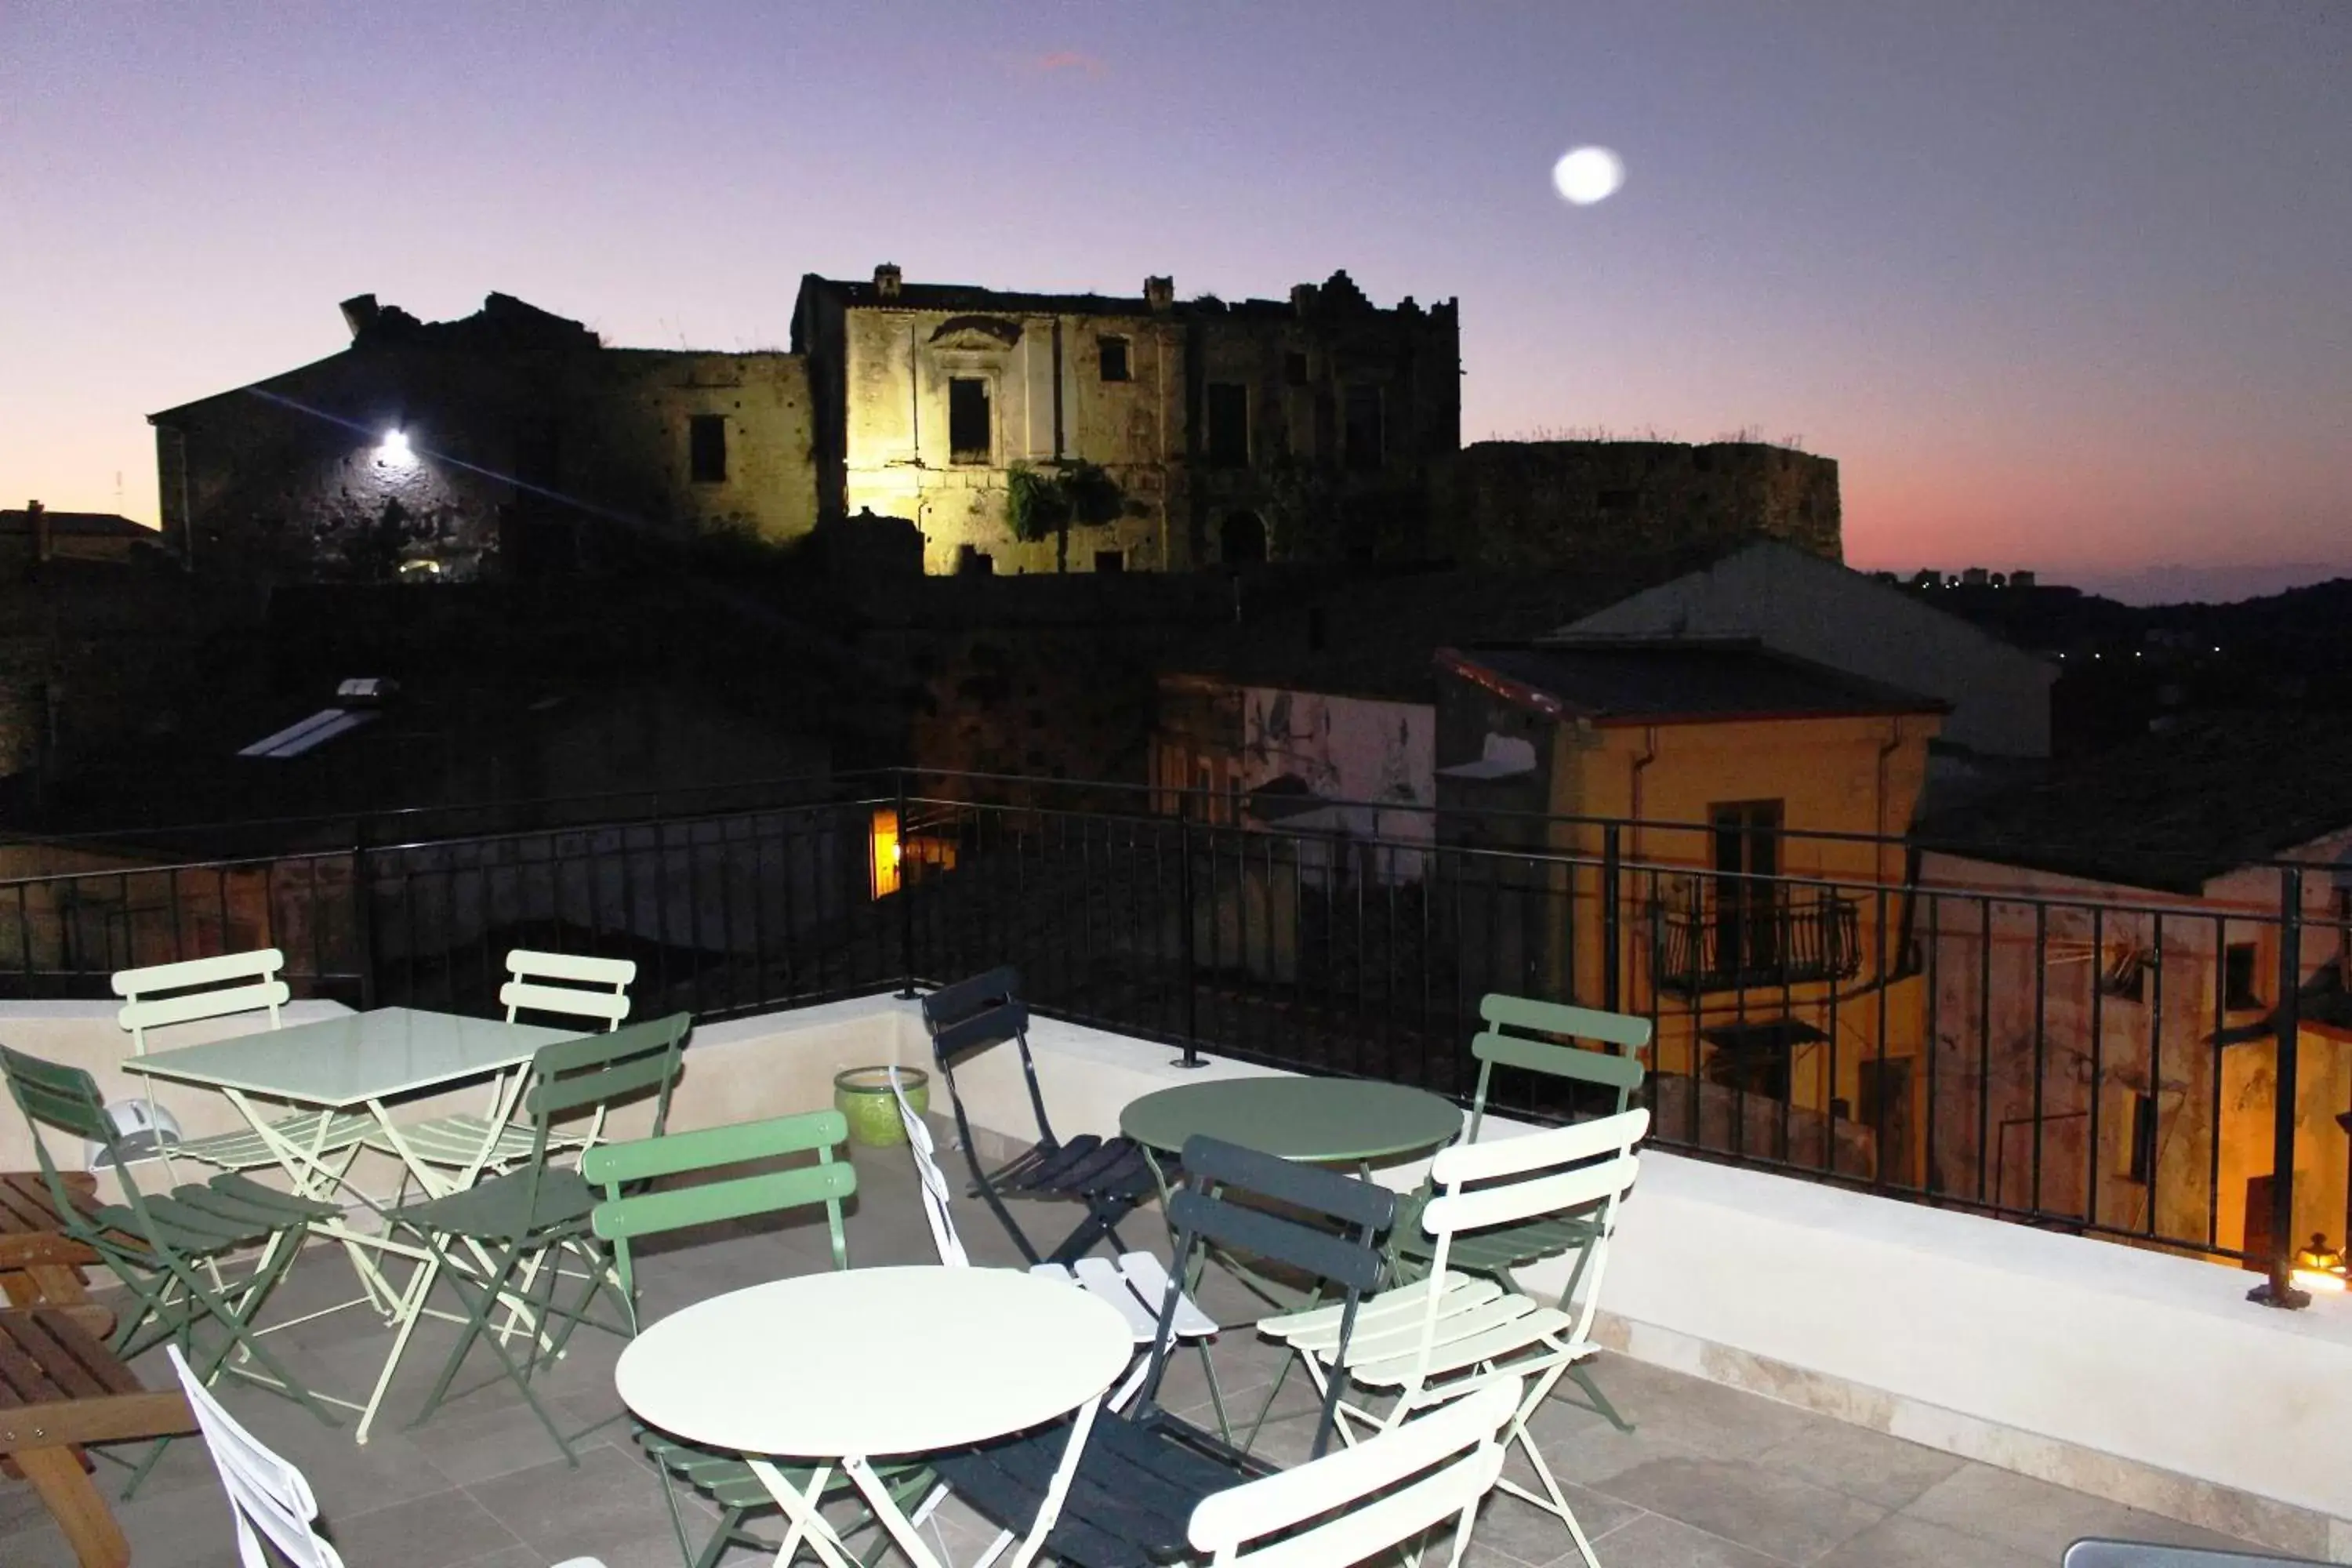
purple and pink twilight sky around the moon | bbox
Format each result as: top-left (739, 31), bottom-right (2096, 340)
top-left (0, 0), bottom-right (2352, 593)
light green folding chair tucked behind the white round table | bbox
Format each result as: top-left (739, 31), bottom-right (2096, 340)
top-left (581, 1109), bottom-right (936, 1568)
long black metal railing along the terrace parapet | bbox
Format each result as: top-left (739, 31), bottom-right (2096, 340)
top-left (0, 771), bottom-right (2352, 1300)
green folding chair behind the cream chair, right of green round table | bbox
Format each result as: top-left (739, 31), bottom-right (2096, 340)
top-left (1397, 992), bottom-right (1651, 1432)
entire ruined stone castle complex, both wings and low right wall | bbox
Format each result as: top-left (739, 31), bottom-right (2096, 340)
top-left (148, 266), bottom-right (1842, 581)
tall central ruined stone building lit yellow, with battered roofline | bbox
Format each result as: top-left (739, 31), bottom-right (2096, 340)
top-left (793, 266), bottom-right (1461, 572)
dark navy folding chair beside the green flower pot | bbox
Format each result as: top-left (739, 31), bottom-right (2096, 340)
top-left (922, 966), bottom-right (1178, 1262)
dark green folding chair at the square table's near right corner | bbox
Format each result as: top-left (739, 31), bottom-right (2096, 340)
top-left (386, 1013), bottom-right (694, 1465)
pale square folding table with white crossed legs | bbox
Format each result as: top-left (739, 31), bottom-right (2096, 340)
top-left (122, 1006), bottom-right (579, 1443)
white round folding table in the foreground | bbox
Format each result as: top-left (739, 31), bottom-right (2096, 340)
top-left (614, 1265), bottom-right (1134, 1563)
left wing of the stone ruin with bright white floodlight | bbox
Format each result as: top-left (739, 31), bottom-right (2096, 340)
top-left (148, 294), bottom-right (816, 581)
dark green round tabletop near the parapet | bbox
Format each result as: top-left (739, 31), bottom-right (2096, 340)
top-left (1120, 1076), bottom-right (1463, 1163)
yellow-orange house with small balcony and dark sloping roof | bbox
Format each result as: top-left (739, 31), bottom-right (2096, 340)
top-left (1437, 640), bottom-right (1945, 1182)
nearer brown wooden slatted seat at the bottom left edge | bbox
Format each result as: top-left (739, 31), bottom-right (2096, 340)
top-left (0, 1307), bottom-right (195, 1568)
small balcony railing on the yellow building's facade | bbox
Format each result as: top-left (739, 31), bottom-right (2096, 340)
top-left (1649, 877), bottom-right (1863, 994)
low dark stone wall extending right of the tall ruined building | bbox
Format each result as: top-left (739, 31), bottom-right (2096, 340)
top-left (1437, 442), bottom-right (1844, 569)
